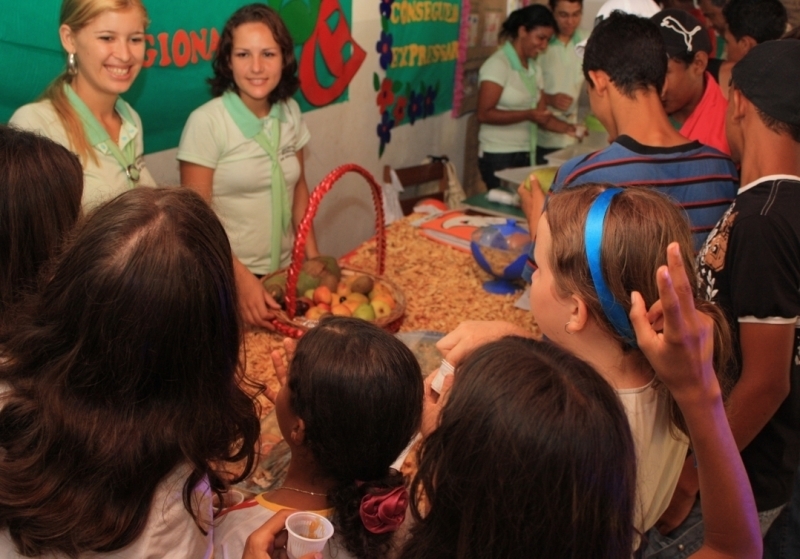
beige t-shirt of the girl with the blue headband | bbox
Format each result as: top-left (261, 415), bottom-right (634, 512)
top-left (617, 381), bottom-right (689, 533)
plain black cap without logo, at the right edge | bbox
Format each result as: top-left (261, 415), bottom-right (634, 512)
top-left (732, 39), bottom-right (800, 126)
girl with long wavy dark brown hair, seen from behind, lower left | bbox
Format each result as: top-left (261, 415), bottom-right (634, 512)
top-left (0, 188), bottom-right (259, 558)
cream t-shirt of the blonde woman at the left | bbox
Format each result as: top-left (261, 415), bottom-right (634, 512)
top-left (8, 101), bottom-right (156, 211)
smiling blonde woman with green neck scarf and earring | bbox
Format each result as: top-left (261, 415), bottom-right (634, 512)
top-left (9, 0), bottom-right (155, 210)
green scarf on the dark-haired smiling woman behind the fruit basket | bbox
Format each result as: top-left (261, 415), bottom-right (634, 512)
top-left (222, 91), bottom-right (292, 272)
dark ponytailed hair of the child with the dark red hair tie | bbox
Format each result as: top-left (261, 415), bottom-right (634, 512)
top-left (288, 317), bottom-right (423, 559)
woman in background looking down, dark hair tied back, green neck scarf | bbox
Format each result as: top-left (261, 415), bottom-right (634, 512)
top-left (477, 4), bottom-right (575, 188)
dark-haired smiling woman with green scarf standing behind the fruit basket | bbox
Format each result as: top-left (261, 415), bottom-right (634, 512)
top-left (178, 4), bottom-right (319, 329)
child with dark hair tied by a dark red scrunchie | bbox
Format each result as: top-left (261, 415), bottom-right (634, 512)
top-left (214, 317), bottom-right (423, 559)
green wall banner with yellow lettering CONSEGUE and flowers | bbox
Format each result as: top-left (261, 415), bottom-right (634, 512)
top-left (373, 0), bottom-right (461, 156)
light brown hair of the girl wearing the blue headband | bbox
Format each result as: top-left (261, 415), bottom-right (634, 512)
top-left (546, 184), bottom-right (731, 432)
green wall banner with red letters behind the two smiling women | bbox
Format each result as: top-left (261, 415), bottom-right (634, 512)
top-left (0, 0), bottom-right (366, 153)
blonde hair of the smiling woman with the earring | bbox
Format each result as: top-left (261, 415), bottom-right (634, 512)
top-left (41, 0), bottom-right (150, 164)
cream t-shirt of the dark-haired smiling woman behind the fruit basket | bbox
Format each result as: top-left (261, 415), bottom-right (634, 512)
top-left (177, 97), bottom-right (311, 274)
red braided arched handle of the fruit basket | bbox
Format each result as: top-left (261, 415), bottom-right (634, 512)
top-left (273, 163), bottom-right (386, 322)
